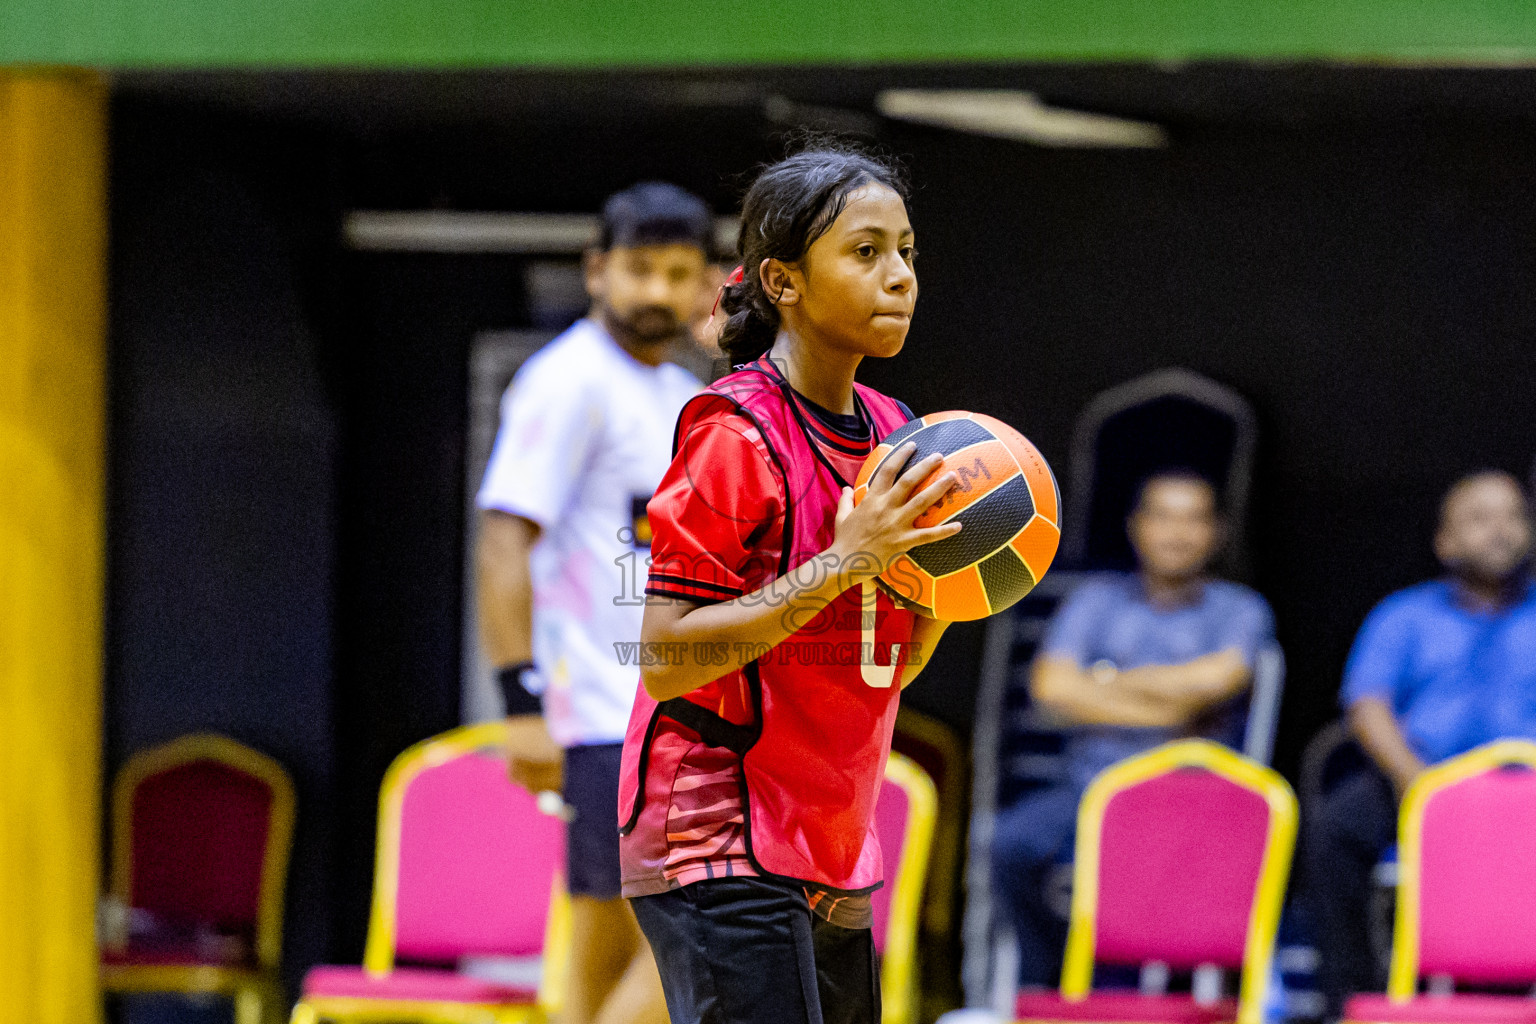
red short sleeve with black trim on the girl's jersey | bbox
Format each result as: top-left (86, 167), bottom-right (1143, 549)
top-left (645, 399), bottom-right (785, 603)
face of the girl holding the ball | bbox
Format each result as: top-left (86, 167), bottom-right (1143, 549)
top-left (763, 184), bottom-right (917, 356)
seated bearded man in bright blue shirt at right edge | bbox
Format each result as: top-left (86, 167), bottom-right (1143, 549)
top-left (1303, 471), bottom-right (1536, 1016)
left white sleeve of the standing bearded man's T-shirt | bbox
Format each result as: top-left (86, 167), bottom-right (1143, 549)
top-left (475, 353), bottom-right (602, 530)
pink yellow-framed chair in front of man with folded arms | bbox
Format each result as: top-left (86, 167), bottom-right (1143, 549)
top-left (1015, 740), bottom-right (1296, 1024)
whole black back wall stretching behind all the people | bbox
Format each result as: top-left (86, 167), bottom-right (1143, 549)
top-left (108, 68), bottom-right (1536, 994)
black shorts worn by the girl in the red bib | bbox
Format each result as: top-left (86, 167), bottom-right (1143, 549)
top-left (630, 878), bottom-right (880, 1024)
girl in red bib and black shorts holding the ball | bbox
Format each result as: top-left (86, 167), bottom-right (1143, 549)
top-left (619, 149), bottom-right (960, 1024)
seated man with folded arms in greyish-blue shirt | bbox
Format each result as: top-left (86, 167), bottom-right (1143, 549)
top-left (992, 471), bottom-right (1273, 986)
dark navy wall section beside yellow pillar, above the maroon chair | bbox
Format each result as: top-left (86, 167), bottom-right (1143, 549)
top-left (106, 108), bottom-right (343, 994)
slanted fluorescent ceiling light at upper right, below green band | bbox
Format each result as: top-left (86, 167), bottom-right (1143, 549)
top-left (876, 89), bottom-right (1167, 149)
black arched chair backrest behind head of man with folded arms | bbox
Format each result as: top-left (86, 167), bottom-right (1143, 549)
top-left (1061, 368), bottom-right (1258, 570)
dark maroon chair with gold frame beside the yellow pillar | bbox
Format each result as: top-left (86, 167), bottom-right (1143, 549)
top-left (101, 732), bottom-right (293, 1024)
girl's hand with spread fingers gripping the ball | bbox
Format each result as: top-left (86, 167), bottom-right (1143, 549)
top-left (831, 441), bottom-right (960, 582)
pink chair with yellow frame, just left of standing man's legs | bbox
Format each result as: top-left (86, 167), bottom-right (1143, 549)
top-left (293, 722), bottom-right (570, 1024)
